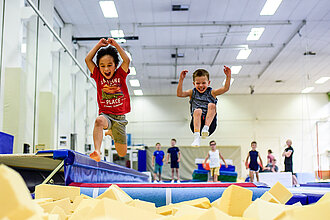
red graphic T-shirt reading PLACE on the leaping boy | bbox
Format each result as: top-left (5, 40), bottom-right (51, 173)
top-left (91, 66), bottom-right (131, 115)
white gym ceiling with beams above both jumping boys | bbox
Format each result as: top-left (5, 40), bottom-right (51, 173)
top-left (55, 0), bottom-right (330, 95)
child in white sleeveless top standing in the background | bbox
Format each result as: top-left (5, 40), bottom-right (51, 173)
top-left (203, 141), bottom-right (228, 182)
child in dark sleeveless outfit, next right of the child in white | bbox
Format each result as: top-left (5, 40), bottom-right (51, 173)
top-left (245, 141), bottom-right (264, 183)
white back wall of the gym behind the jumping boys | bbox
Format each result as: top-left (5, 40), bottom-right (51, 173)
top-left (127, 94), bottom-right (330, 176)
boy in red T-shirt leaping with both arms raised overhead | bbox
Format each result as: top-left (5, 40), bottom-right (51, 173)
top-left (85, 38), bottom-right (131, 162)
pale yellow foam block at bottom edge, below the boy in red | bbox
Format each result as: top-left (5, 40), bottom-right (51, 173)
top-left (84, 198), bottom-right (162, 220)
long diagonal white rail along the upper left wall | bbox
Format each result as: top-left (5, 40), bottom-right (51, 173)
top-left (26, 0), bottom-right (96, 88)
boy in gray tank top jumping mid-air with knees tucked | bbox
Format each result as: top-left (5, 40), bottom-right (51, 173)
top-left (177, 66), bottom-right (231, 146)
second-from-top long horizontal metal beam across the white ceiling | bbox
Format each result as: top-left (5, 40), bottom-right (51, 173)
top-left (142, 44), bottom-right (274, 50)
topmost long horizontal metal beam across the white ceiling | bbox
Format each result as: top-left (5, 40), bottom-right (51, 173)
top-left (137, 20), bottom-right (292, 28)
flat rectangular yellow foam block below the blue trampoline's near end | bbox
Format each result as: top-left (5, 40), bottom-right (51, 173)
top-left (35, 184), bottom-right (80, 201)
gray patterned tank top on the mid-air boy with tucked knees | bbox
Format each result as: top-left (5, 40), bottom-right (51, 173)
top-left (190, 87), bottom-right (218, 115)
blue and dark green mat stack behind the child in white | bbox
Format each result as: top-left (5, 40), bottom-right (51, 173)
top-left (192, 164), bottom-right (237, 182)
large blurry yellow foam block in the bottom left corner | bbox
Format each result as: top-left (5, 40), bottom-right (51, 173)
top-left (0, 164), bottom-right (43, 219)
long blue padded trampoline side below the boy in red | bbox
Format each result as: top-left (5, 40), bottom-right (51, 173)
top-left (37, 149), bottom-right (148, 185)
